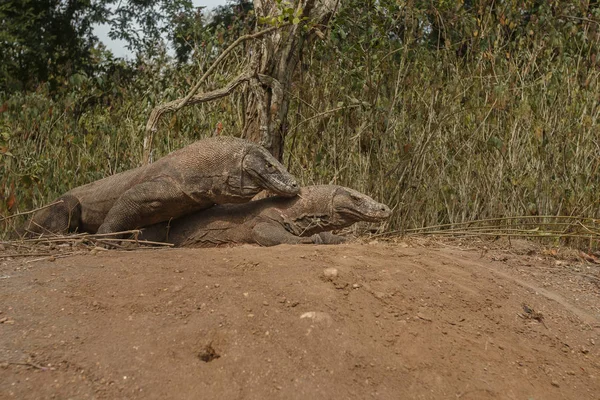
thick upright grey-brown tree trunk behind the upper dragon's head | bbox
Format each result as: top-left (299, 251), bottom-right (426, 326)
top-left (243, 0), bottom-right (341, 161)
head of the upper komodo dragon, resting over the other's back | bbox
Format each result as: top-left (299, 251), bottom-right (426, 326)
top-left (242, 144), bottom-right (300, 197)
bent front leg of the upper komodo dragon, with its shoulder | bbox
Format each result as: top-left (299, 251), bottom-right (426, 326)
top-left (98, 176), bottom-right (199, 234)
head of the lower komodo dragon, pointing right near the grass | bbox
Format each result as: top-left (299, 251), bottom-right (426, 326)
top-left (331, 187), bottom-right (392, 222)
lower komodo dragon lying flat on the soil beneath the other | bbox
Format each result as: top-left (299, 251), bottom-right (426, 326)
top-left (139, 185), bottom-right (391, 247)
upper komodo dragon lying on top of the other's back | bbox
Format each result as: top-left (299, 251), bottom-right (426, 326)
top-left (27, 136), bottom-right (300, 233)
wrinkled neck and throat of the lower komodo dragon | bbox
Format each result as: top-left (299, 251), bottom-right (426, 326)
top-left (281, 187), bottom-right (356, 236)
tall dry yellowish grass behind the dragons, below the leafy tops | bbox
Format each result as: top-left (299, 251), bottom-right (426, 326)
top-left (0, 3), bottom-right (600, 247)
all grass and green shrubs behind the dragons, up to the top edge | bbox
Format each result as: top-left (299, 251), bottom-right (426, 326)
top-left (0, 0), bottom-right (600, 245)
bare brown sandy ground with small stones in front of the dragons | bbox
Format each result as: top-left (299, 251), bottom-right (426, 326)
top-left (0, 241), bottom-right (600, 400)
